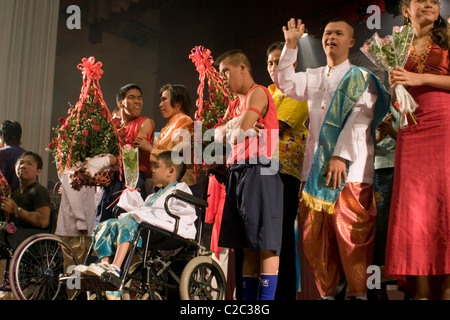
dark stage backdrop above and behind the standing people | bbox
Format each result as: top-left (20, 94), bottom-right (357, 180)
top-left (49, 0), bottom-right (450, 179)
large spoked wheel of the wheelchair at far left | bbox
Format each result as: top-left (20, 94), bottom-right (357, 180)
top-left (9, 233), bottom-right (78, 300)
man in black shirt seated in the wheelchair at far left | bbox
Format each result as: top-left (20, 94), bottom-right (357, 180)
top-left (0, 151), bottom-right (51, 250)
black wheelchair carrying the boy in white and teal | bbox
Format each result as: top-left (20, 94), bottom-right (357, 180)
top-left (60, 169), bottom-right (226, 300)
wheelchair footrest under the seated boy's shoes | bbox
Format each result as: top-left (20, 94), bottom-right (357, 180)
top-left (59, 272), bottom-right (122, 292)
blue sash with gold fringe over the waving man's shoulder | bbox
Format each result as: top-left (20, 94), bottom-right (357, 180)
top-left (302, 66), bottom-right (391, 213)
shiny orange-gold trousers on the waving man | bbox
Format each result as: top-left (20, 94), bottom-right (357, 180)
top-left (299, 183), bottom-right (376, 296)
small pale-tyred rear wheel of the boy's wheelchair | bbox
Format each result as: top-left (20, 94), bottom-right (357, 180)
top-left (180, 256), bottom-right (226, 300)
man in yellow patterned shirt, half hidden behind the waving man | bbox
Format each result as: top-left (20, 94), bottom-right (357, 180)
top-left (267, 41), bottom-right (308, 301)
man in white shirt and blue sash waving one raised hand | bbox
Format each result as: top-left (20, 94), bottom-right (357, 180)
top-left (275, 19), bottom-right (390, 299)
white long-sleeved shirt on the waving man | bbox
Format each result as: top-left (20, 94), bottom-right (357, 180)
top-left (275, 46), bottom-right (377, 183)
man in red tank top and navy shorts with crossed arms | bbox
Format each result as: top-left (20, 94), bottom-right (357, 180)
top-left (215, 50), bottom-right (283, 300)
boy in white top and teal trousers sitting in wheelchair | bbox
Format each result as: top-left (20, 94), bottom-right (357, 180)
top-left (79, 150), bottom-right (197, 277)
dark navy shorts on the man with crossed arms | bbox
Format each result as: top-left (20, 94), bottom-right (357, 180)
top-left (218, 164), bottom-right (283, 255)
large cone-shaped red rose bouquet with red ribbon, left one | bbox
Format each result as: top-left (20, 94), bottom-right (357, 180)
top-left (47, 57), bottom-right (121, 189)
